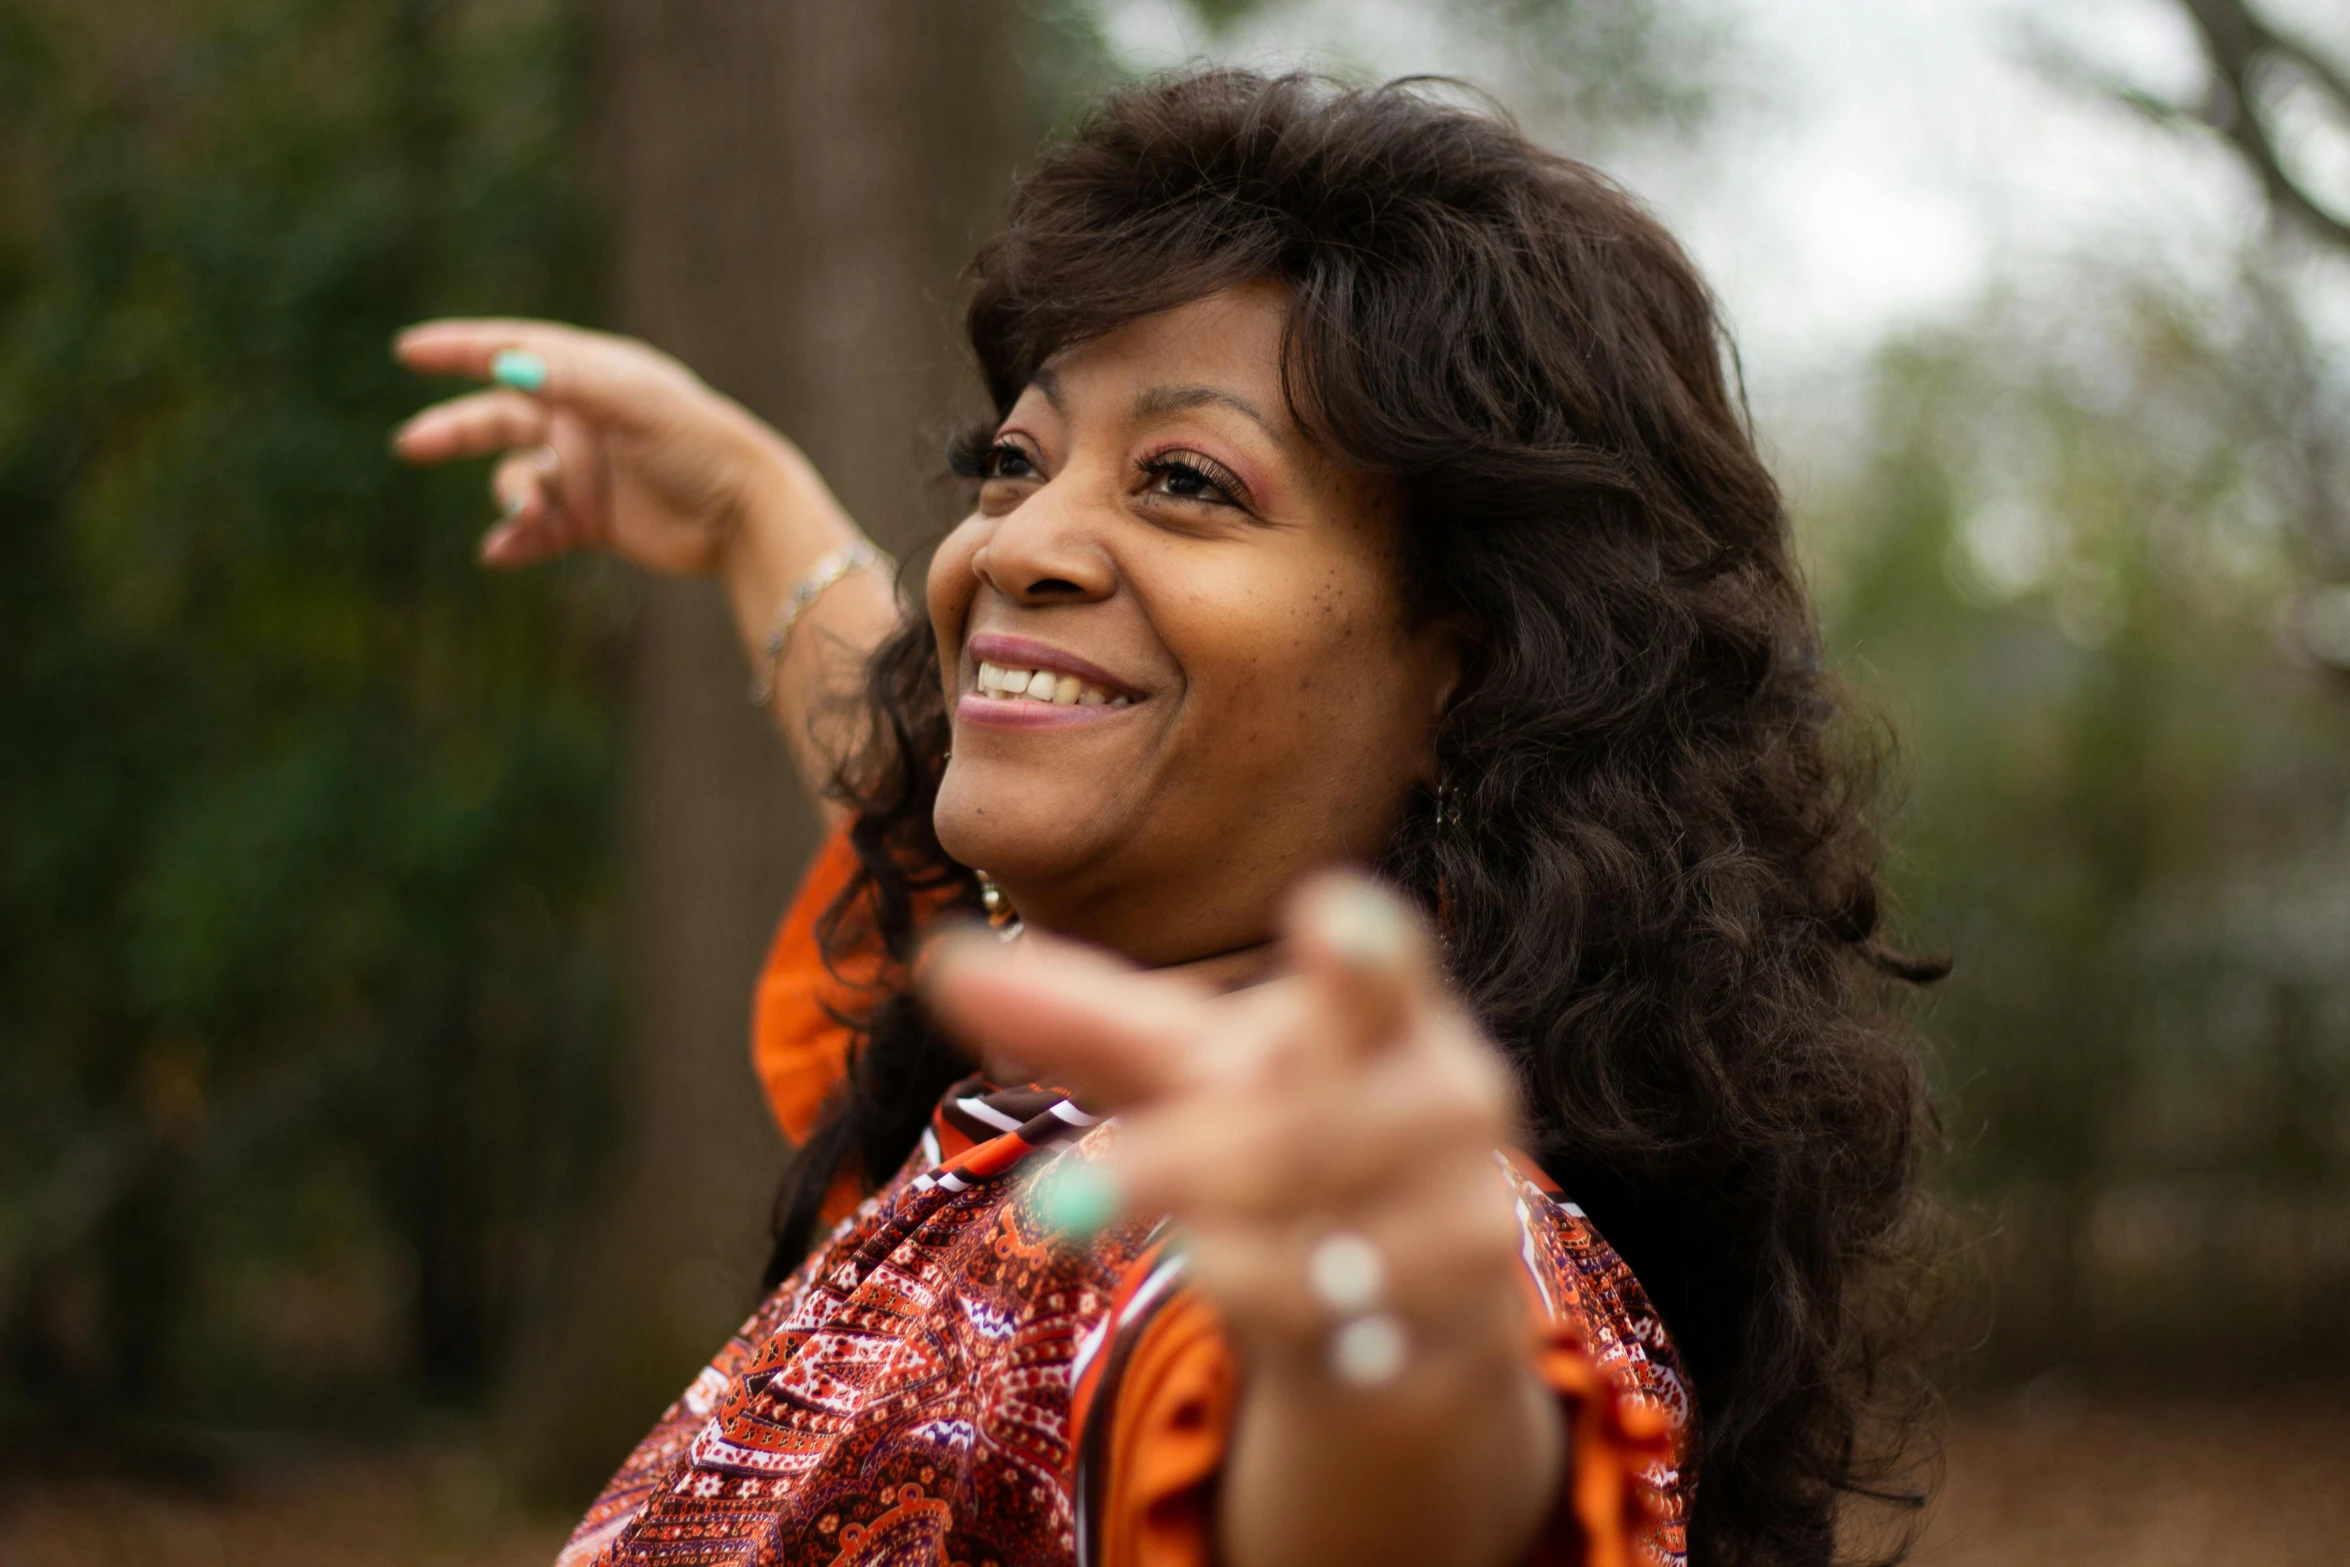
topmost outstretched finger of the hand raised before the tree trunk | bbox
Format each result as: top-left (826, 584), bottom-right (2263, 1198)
top-left (392, 317), bottom-right (691, 428)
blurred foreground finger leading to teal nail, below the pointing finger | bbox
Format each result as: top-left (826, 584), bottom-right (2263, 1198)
top-left (1107, 1041), bottom-right (1511, 1222)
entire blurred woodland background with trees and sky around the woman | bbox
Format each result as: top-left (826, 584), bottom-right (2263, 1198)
top-left (0, 0), bottom-right (2350, 1567)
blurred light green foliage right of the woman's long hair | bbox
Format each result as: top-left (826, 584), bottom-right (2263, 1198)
top-left (1812, 275), bottom-right (2350, 1372)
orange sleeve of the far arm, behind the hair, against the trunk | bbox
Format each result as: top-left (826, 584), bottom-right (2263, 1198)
top-left (750, 829), bottom-right (881, 1142)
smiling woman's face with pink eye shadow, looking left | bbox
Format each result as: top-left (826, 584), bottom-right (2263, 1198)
top-left (928, 284), bottom-right (1459, 963)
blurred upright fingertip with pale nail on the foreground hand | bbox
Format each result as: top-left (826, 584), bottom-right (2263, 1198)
top-left (1288, 874), bottom-right (1445, 1060)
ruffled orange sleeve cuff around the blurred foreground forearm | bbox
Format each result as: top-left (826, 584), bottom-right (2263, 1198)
top-left (1100, 1290), bottom-right (1671, 1567)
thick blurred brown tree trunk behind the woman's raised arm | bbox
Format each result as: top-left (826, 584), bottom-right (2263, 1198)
top-left (503, 0), bottom-right (1036, 1489)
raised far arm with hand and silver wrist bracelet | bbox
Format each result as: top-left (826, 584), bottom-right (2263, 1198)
top-left (392, 320), bottom-right (898, 796)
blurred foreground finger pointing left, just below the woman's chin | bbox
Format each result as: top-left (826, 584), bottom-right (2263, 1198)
top-left (917, 930), bottom-right (1206, 1111)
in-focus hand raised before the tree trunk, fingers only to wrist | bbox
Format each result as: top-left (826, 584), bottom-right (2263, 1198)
top-left (392, 320), bottom-right (794, 576)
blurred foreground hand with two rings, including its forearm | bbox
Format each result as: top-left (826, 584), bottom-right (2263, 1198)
top-left (921, 876), bottom-right (1563, 1567)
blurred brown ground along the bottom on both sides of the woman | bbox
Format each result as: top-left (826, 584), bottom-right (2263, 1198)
top-left (0, 1388), bottom-right (2350, 1567)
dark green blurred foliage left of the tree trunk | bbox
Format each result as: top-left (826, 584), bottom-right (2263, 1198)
top-left (0, 0), bottom-right (616, 1428)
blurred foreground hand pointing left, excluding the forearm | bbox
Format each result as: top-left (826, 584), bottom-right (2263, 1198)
top-left (926, 876), bottom-right (1523, 1374)
